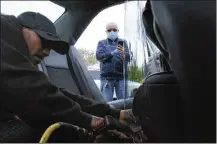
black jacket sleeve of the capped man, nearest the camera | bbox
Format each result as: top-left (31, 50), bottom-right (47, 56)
top-left (0, 16), bottom-right (92, 129)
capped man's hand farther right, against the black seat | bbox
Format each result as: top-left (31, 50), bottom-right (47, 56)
top-left (119, 109), bottom-right (136, 125)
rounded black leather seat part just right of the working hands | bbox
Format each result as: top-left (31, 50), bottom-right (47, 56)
top-left (133, 72), bottom-right (181, 143)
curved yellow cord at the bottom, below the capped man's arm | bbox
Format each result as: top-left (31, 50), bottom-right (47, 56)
top-left (39, 123), bottom-right (61, 143)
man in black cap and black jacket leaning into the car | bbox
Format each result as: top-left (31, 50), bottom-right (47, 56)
top-left (0, 12), bottom-right (132, 142)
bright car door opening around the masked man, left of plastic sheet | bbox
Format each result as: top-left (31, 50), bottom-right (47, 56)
top-left (75, 4), bottom-right (125, 99)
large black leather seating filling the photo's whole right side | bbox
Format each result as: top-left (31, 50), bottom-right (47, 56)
top-left (134, 1), bottom-right (216, 143)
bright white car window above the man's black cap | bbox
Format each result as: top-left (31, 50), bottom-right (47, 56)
top-left (1, 1), bottom-right (65, 22)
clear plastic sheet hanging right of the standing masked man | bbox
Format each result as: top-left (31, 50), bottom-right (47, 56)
top-left (124, 1), bottom-right (147, 97)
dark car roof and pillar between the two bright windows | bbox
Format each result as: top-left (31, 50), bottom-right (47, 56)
top-left (52, 0), bottom-right (124, 44)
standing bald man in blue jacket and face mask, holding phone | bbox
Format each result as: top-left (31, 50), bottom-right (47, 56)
top-left (96, 22), bottom-right (130, 101)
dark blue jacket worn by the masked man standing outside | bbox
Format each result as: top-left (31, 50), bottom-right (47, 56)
top-left (96, 38), bottom-right (130, 79)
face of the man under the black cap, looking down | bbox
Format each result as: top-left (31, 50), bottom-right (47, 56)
top-left (23, 28), bottom-right (51, 64)
